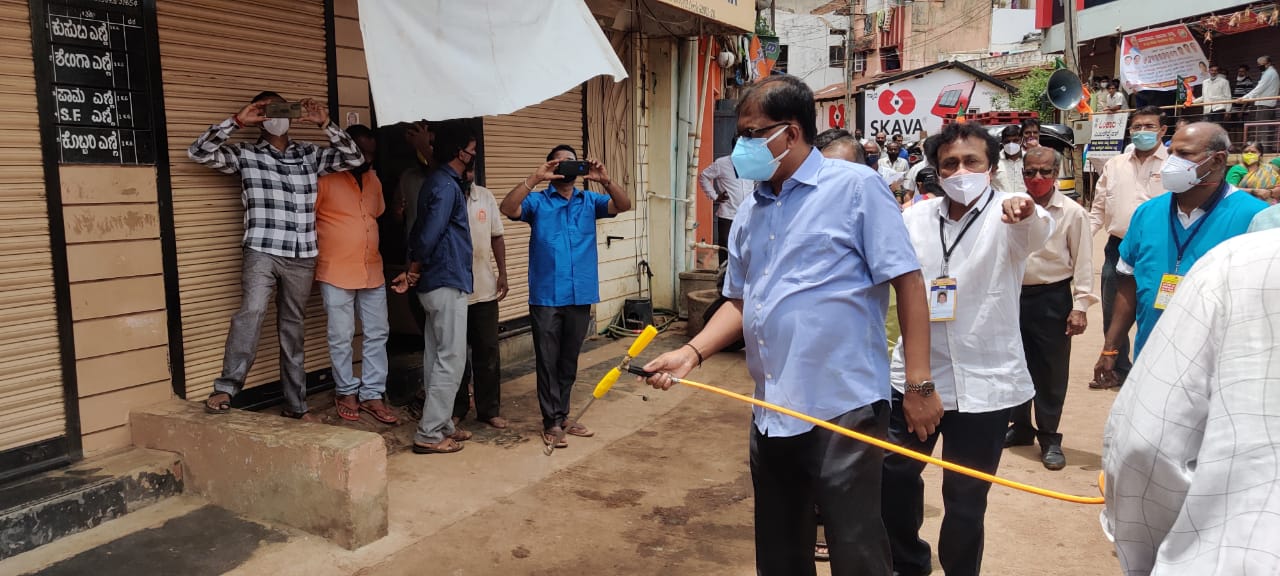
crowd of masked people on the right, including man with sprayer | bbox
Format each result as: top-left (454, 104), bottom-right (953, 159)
top-left (675, 73), bottom-right (1280, 575)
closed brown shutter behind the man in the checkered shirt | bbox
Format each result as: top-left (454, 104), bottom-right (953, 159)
top-left (156, 0), bottom-right (329, 398)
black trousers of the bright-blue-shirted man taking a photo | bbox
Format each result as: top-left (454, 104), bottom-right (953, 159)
top-left (529, 306), bottom-right (591, 430)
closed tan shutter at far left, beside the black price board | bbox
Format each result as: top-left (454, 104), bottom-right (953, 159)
top-left (0, 0), bottom-right (67, 450)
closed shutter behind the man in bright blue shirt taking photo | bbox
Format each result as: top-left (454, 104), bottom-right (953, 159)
top-left (484, 87), bottom-right (585, 321)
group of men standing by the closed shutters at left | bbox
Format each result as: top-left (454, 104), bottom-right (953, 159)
top-left (188, 92), bottom-right (631, 453)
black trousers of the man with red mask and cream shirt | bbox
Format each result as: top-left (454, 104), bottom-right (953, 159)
top-left (1012, 279), bottom-right (1074, 449)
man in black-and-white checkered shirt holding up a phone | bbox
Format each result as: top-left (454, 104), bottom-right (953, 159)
top-left (187, 92), bottom-right (365, 419)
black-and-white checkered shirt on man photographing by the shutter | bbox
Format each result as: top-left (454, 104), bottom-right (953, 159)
top-left (187, 118), bottom-right (365, 259)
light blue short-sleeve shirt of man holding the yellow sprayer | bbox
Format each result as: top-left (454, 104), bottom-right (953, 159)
top-left (724, 150), bottom-right (920, 436)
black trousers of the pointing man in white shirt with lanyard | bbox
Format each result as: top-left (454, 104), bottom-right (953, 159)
top-left (881, 392), bottom-right (1009, 576)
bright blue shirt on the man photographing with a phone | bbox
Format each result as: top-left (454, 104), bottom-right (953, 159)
top-left (520, 187), bottom-right (613, 306)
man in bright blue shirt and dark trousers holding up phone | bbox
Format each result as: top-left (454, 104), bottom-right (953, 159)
top-left (499, 145), bottom-right (631, 448)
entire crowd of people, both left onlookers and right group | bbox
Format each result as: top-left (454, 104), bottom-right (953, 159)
top-left (188, 72), bottom-right (1280, 576)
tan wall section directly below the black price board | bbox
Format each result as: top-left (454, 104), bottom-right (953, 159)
top-left (59, 165), bottom-right (173, 456)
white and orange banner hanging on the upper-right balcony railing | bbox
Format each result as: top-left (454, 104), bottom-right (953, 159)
top-left (1120, 24), bottom-right (1208, 93)
